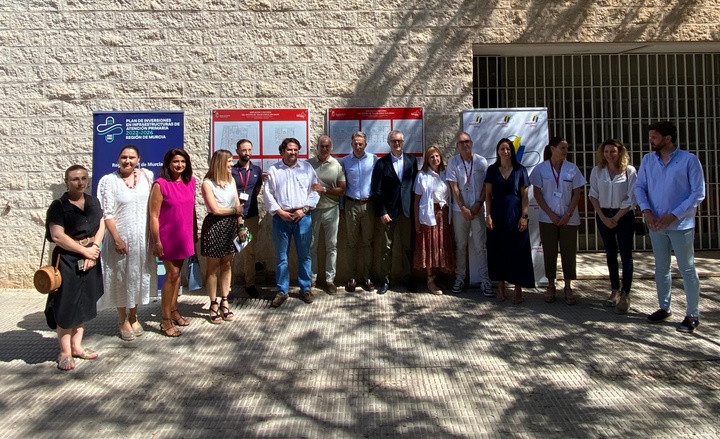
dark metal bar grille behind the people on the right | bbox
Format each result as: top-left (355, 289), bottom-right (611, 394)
top-left (473, 53), bottom-right (720, 251)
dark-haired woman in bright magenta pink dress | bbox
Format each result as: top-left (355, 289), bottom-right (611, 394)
top-left (149, 148), bottom-right (197, 337)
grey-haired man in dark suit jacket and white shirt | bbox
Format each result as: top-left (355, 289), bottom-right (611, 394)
top-left (370, 130), bottom-right (417, 294)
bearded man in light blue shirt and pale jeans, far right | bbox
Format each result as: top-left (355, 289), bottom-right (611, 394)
top-left (635, 122), bottom-right (705, 333)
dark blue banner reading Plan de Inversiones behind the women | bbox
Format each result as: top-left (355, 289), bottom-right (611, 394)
top-left (92, 111), bottom-right (185, 195)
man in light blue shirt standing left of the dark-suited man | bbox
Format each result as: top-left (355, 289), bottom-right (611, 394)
top-left (340, 131), bottom-right (378, 292)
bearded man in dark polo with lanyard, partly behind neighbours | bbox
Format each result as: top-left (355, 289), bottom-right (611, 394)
top-left (231, 139), bottom-right (262, 297)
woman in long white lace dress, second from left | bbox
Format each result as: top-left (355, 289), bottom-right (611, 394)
top-left (98, 145), bottom-right (157, 341)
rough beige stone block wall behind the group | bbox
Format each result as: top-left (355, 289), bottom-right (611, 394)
top-left (0, 0), bottom-right (720, 288)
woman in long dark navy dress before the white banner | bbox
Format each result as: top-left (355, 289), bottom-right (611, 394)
top-left (485, 139), bottom-right (535, 305)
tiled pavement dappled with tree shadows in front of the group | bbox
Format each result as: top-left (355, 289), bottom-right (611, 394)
top-left (0, 259), bottom-right (720, 438)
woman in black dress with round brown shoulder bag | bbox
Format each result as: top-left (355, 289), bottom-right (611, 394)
top-left (45, 165), bottom-right (105, 370)
